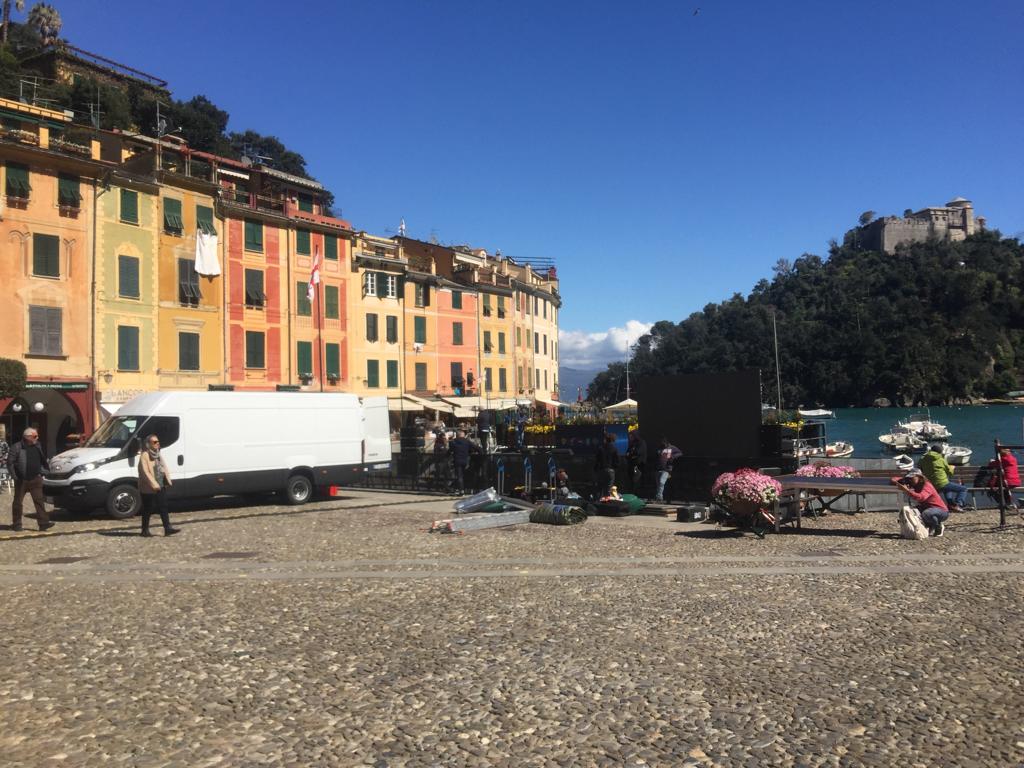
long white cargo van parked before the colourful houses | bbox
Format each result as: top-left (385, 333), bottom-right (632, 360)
top-left (43, 392), bottom-right (391, 518)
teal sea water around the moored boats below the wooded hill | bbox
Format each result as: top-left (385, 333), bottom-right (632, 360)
top-left (824, 404), bottom-right (1024, 465)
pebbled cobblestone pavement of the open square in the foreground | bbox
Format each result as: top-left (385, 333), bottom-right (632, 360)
top-left (0, 493), bottom-right (1024, 768)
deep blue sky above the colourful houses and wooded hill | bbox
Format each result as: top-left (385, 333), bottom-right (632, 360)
top-left (46, 0), bottom-right (1024, 365)
